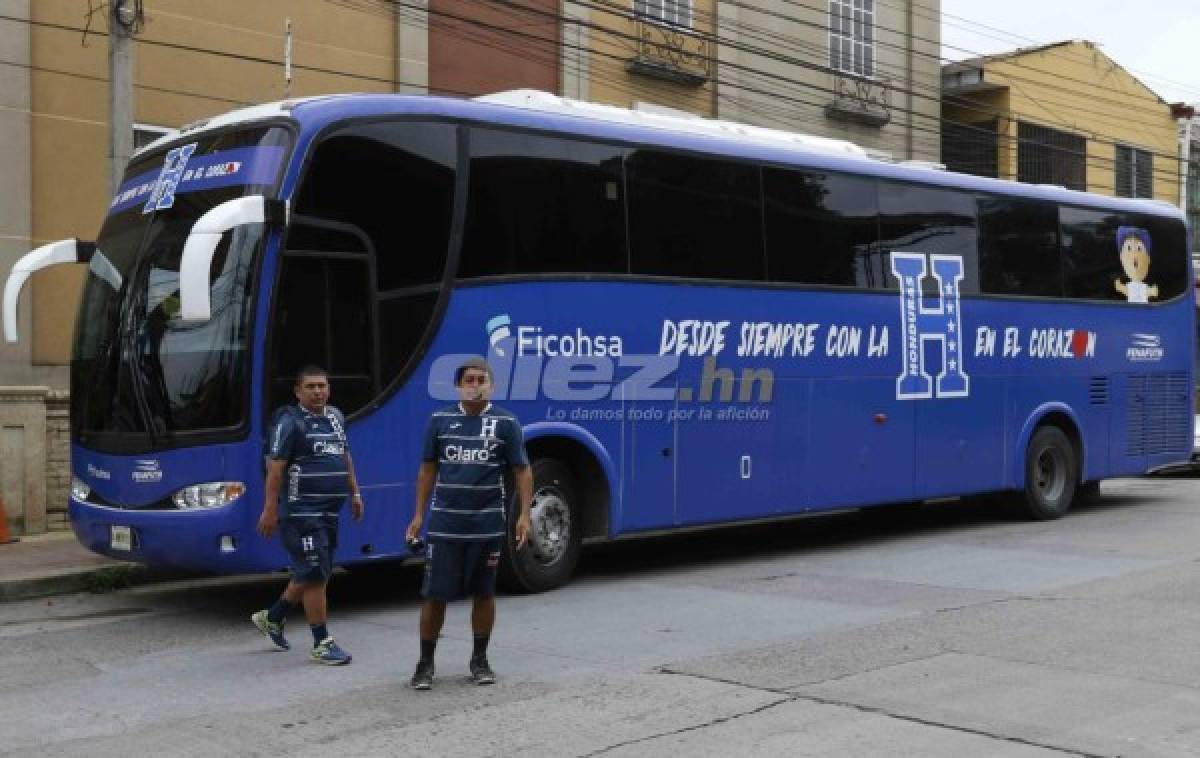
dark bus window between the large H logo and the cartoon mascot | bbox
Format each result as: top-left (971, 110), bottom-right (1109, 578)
top-left (978, 195), bottom-right (1062, 297)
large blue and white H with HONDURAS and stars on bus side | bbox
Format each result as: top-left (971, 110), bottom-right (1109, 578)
top-left (892, 253), bottom-right (971, 401)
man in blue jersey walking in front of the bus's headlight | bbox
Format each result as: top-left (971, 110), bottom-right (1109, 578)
top-left (250, 366), bottom-right (362, 666)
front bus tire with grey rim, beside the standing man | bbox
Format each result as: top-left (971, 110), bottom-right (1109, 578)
top-left (499, 458), bottom-right (583, 592)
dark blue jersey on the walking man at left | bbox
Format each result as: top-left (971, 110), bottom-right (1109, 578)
top-left (266, 405), bottom-right (350, 517)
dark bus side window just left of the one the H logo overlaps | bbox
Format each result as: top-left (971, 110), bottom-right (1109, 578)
top-left (763, 168), bottom-right (880, 288)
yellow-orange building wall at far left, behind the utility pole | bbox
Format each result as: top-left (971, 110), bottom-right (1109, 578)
top-left (30, 0), bottom-right (397, 365)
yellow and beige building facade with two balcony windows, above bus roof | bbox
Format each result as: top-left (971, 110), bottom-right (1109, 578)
top-left (563, 0), bottom-right (941, 161)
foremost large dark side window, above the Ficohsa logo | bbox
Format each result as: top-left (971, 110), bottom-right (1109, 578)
top-left (458, 128), bottom-right (628, 278)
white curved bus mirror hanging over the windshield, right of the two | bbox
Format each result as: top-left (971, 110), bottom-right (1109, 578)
top-left (179, 194), bottom-right (288, 323)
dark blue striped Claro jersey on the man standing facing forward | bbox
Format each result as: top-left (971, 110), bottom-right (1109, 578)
top-left (421, 403), bottom-right (529, 541)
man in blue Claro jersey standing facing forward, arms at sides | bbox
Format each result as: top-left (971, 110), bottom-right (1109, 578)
top-left (407, 357), bottom-right (533, 690)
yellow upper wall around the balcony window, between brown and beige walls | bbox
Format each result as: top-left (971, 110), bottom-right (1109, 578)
top-left (580, 0), bottom-right (716, 116)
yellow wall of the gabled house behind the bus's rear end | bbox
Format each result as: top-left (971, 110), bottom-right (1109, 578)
top-left (984, 42), bottom-right (1180, 203)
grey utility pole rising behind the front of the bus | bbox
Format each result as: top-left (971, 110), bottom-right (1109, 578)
top-left (108, 0), bottom-right (142, 194)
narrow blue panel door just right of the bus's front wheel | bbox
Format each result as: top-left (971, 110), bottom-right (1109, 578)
top-left (619, 385), bottom-right (678, 531)
